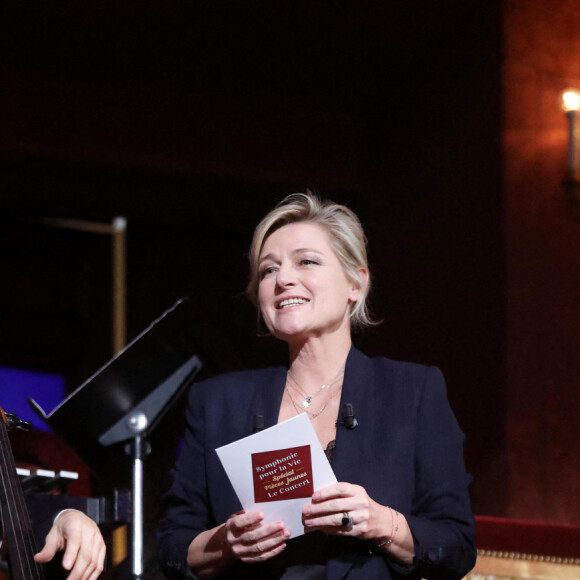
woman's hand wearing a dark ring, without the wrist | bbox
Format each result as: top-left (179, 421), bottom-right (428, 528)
top-left (302, 482), bottom-right (391, 539)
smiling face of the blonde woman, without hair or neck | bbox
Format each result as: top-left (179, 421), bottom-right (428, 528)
top-left (258, 222), bottom-right (359, 342)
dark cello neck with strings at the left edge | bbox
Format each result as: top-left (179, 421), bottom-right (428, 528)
top-left (0, 408), bottom-right (44, 580)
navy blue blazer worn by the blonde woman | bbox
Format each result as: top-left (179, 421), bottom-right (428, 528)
top-left (158, 347), bottom-right (476, 580)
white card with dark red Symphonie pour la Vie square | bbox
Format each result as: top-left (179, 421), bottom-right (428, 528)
top-left (216, 413), bottom-right (336, 538)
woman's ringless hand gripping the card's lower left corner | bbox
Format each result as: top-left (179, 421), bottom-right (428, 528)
top-left (224, 512), bottom-right (290, 562)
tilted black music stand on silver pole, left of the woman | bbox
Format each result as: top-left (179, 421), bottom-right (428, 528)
top-left (29, 299), bottom-right (202, 578)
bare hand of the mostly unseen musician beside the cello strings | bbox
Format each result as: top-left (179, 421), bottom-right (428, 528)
top-left (34, 510), bottom-right (106, 580)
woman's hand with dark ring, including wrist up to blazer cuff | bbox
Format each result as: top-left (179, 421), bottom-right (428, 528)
top-left (302, 482), bottom-right (415, 565)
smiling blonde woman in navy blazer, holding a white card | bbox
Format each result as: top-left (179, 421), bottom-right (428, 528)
top-left (158, 194), bottom-right (476, 580)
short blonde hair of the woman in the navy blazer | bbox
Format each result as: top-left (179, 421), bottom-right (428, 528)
top-left (246, 191), bottom-right (374, 329)
